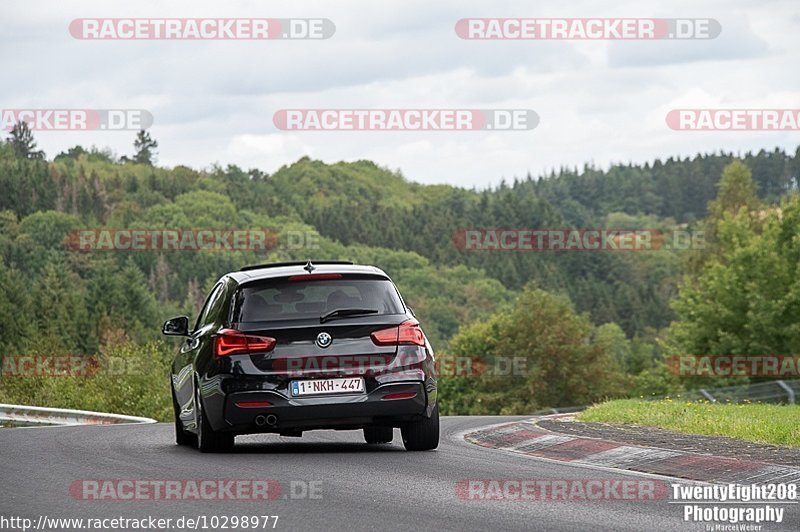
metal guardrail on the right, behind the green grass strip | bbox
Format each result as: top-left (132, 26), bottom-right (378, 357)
top-left (532, 379), bottom-right (800, 416)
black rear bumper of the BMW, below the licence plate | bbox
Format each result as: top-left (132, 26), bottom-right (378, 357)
top-left (212, 381), bottom-right (429, 434)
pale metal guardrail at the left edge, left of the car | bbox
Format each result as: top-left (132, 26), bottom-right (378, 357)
top-left (0, 404), bottom-right (156, 425)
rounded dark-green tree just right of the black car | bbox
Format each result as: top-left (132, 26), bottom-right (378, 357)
top-left (441, 284), bottom-right (630, 414)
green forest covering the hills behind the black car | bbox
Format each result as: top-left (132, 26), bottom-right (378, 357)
top-left (0, 124), bottom-right (800, 419)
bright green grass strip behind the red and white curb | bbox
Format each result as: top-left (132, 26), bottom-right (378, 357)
top-left (578, 399), bottom-right (800, 446)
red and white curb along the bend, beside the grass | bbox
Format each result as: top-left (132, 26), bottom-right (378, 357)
top-left (464, 419), bottom-right (800, 484)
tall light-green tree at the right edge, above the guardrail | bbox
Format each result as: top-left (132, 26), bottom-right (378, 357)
top-left (666, 189), bottom-right (800, 385)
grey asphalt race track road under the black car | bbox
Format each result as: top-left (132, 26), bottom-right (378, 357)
top-left (0, 417), bottom-right (800, 531)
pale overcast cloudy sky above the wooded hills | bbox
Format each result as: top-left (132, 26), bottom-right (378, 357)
top-left (0, 0), bottom-right (800, 187)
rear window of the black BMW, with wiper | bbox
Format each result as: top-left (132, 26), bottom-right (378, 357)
top-left (232, 277), bottom-right (404, 323)
